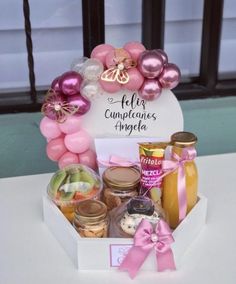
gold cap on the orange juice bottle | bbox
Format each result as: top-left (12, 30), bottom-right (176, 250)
top-left (171, 131), bottom-right (197, 147)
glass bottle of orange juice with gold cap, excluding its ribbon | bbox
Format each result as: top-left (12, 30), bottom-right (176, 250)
top-left (162, 132), bottom-right (198, 229)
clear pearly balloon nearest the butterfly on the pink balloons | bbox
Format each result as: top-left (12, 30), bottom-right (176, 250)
top-left (82, 58), bottom-right (104, 81)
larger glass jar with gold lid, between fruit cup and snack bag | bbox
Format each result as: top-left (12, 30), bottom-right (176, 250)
top-left (102, 166), bottom-right (140, 210)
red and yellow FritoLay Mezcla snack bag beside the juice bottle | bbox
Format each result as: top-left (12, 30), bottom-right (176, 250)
top-left (139, 142), bottom-right (168, 205)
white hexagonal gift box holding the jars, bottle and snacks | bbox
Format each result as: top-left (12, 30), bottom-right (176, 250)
top-left (43, 195), bottom-right (207, 270)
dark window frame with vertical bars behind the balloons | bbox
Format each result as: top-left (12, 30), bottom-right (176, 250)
top-left (0, 0), bottom-right (236, 113)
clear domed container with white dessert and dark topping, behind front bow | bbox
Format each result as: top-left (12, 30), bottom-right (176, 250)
top-left (109, 196), bottom-right (165, 238)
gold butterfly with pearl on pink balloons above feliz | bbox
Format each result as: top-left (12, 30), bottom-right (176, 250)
top-left (101, 48), bottom-right (136, 84)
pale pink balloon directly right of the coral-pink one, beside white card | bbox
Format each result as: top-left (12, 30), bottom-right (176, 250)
top-left (64, 130), bottom-right (91, 154)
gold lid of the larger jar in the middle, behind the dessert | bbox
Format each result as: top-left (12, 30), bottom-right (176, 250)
top-left (102, 166), bottom-right (140, 190)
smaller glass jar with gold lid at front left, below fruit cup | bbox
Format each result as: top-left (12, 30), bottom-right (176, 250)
top-left (73, 200), bottom-right (109, 238)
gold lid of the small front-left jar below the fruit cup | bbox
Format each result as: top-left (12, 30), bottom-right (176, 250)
top-left (75, 200), bottom-right (107, 224)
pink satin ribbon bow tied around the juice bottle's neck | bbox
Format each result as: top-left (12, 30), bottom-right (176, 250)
top-left (162, 147), bottom-right (197, 221)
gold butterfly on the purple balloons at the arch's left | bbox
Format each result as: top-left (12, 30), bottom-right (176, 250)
top-left (41, 89), bottom-right (79, 123)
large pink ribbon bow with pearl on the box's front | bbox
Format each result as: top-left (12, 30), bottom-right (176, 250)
top-left (119, 219), bottom-right (176, 278)
